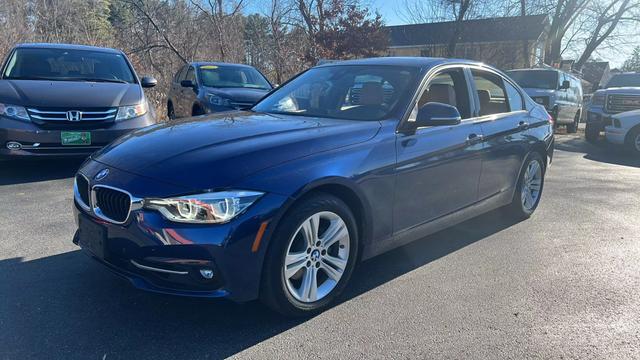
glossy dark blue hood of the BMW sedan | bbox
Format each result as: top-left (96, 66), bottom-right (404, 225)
top-left (93, 112), bottom-right (380, 190)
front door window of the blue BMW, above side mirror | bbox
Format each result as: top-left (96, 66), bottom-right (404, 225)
top-left (411, 69), bottom-right (471, 119)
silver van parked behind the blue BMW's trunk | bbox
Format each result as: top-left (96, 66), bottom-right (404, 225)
top-left (507, 68), bottom-right (582, 133)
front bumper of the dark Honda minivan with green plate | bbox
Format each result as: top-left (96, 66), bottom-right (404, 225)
top-left (0, 112), bottom-right (156, 158)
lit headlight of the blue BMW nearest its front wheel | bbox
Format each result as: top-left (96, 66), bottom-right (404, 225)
top-left (144, 190), bottom-right (264, 224)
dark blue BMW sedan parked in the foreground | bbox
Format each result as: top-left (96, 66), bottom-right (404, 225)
top-left (74, 58), bottom-right (554, 315)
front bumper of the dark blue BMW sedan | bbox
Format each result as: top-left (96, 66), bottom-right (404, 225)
top-left (74, 162), bottom-right (288, 302)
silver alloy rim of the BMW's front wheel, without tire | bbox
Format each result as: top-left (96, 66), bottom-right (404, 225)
top-left (283, 211), bottom-right (350, 303)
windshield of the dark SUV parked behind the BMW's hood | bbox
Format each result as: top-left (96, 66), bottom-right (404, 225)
top-left (198, 65), bottom-right (271, 90)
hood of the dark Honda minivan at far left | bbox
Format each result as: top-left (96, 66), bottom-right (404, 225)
top-left (0, 80), bottom-right (143, 108)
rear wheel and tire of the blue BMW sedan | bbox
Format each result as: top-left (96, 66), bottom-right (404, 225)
top-left (504, 152), bottom-right (545, 220)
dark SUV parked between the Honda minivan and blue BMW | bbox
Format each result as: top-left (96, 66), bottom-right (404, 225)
top-left (167, 62), bottom-right (273, 119)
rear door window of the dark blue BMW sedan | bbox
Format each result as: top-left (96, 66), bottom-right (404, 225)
top-left (471, 70), bottom-right (510, 116)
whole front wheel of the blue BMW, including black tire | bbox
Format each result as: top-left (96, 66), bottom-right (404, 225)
top-left (260, 193), bottom-right (359, 317)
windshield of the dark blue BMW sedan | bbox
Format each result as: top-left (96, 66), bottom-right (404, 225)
top-left (253, 65), bottom-right (417, 120)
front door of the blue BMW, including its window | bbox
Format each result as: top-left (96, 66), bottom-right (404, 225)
top-left (394, 67), bottom-right (483, 233)
